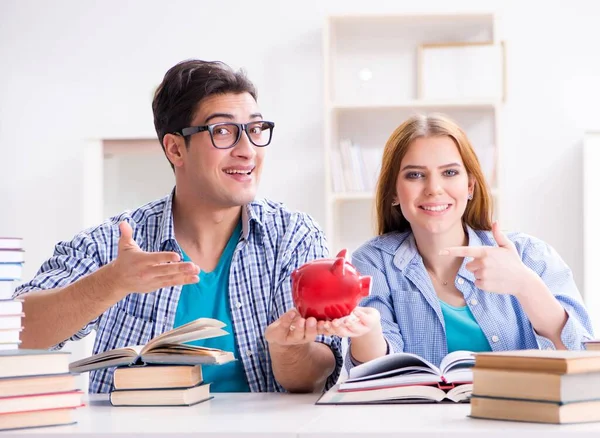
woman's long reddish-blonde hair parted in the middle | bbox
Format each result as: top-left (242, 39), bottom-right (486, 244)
top-left (375, 114), bottom-right (492, 235)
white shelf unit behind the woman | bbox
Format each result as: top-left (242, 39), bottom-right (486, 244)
top-left (323, 13), bottom-right (502, 253)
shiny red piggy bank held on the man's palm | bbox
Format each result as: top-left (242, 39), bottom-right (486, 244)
top-left (292, 249), bottom-right (371, 321)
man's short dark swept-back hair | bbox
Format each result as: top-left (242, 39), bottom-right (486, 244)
top-left (152, 59), bottom-right (257, 167)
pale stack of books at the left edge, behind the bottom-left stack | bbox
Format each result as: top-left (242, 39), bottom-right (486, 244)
top-left (0, 237), bottom-right (25, 351)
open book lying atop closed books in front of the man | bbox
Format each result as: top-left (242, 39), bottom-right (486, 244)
top-left (69, 318), bottom-right (235, 373)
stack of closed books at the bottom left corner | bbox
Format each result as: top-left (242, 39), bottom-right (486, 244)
top-left (0, 349), bottom-right (82, 430)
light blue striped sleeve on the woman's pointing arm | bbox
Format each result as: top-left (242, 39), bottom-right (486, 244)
top-left (522, 239), bottom-right (593, 350)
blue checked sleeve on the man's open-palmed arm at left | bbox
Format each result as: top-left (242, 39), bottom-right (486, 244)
top-left (13, 233), bottom-right (101, 350)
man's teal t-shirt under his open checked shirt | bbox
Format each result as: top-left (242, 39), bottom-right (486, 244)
top-left (174, 222), bottom-right (250, 392)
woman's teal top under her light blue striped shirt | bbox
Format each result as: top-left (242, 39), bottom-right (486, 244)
top-left (439, 300), bottom-right (492, 353)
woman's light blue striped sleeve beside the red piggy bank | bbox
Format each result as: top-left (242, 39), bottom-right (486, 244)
top-left (345, 246), bottom-right (404, 369)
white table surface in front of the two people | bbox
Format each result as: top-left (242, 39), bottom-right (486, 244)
top-left (9, 394), bottom-right (600, 438)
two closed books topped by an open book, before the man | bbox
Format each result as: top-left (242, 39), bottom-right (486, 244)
top-left (69, 318), bottom-right (234, 406)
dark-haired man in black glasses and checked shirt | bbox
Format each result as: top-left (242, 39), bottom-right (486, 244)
top-left (15, 60), bottom-right (342, 392)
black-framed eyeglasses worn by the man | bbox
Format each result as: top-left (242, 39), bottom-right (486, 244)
top-left (177, 120), bottom-right (275, 149)
